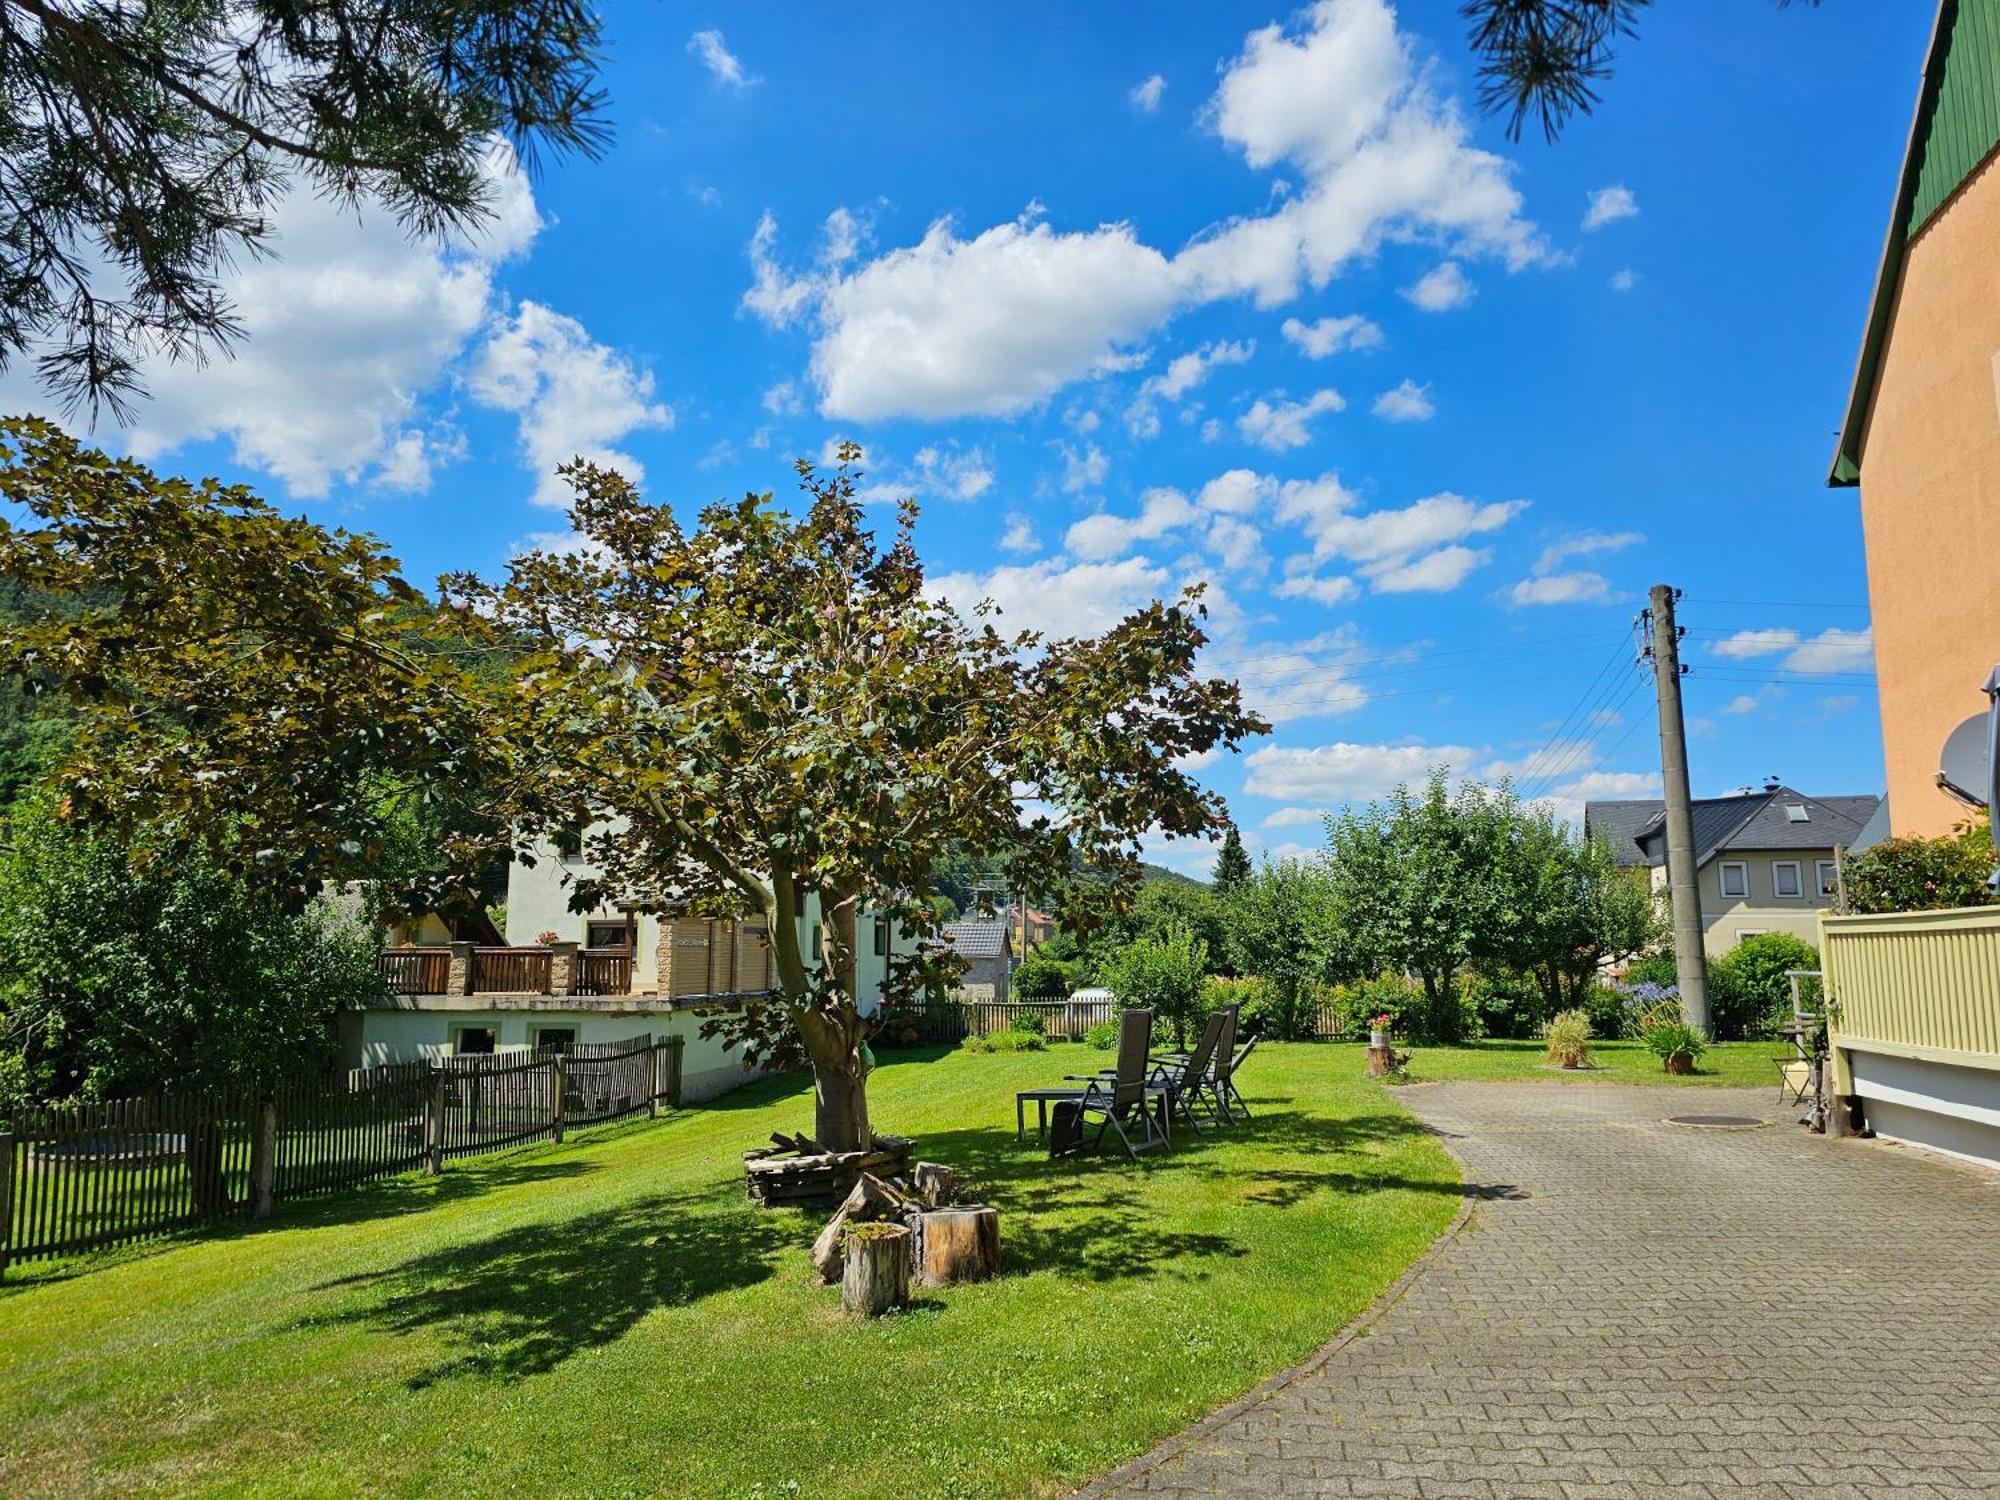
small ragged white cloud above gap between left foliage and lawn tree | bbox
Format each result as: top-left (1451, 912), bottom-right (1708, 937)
top-left (468, 302), bottom-right (674, 506)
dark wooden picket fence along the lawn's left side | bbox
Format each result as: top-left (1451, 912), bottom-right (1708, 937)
top-left (0, 1036), bottom-right (686, 1274)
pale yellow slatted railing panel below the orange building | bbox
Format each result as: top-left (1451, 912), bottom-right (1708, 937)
top-left (1820, 906), bottom-right (2000, 1094)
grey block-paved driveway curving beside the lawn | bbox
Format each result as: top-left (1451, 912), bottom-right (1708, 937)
top-left (1104, 1084), bottom-right (2000, 1500)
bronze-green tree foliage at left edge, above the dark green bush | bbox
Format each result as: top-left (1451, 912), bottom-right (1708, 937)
top-left (0, 420), bottom-right (512, 908)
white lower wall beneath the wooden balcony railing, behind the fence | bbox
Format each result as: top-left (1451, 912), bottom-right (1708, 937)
top-left (340, 996), bottom-right (756, 1104)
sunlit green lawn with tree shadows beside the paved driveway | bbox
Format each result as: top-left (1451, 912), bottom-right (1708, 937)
top-left (0, 1046), bottom-right (1472, 1500)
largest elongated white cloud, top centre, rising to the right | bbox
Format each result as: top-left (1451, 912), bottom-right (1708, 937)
top-left (744, 0), bottom-right (1550, 420)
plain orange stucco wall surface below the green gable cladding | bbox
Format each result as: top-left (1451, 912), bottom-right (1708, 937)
top-left (1860, 148), bottom-right (2000, 834)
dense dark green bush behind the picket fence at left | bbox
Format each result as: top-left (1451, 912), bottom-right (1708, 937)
top-left (0, 804), bottom-right (380, 1098)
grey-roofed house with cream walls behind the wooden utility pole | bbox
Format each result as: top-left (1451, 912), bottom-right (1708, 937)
top-left (1584, 782), bottom-right (1882, 956)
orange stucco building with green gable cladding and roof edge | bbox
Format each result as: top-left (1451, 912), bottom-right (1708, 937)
top-left (1830, 0), bottom-right (2000, 834)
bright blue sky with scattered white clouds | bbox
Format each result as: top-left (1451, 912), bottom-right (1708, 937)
top-left (6, 0), bottom-right (1930, 872)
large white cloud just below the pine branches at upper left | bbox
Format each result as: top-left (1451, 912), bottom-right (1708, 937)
top-left (124, 146), bottom-right (542, 496)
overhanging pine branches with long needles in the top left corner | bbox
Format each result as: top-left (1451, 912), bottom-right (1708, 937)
top-left (0, 0), bottom-right (606, 412)
